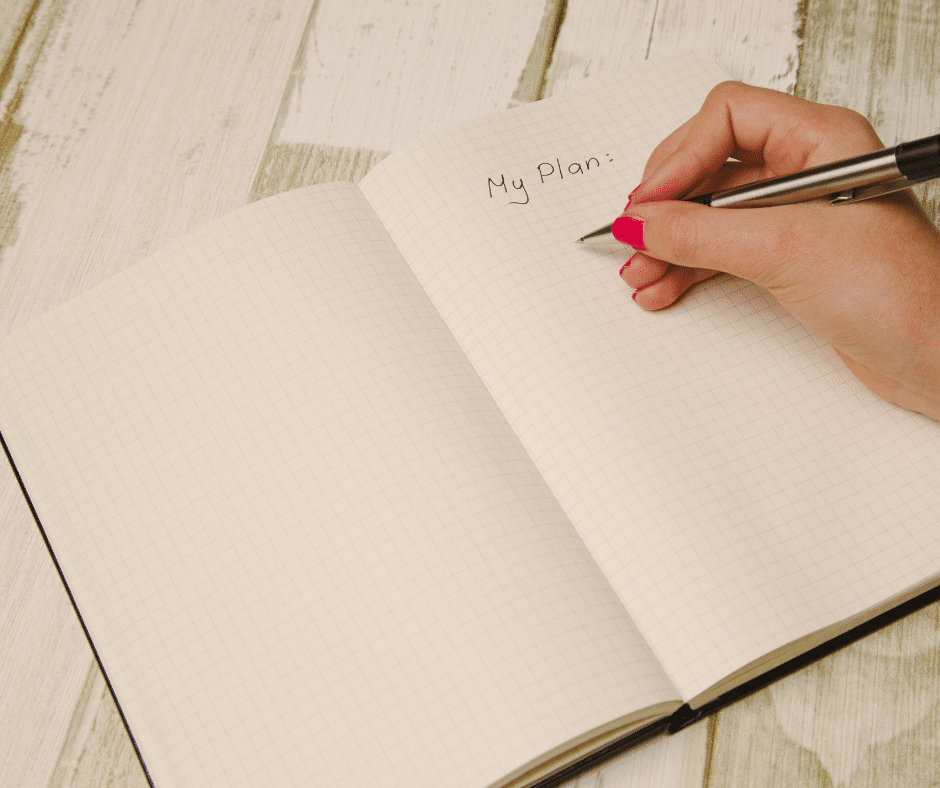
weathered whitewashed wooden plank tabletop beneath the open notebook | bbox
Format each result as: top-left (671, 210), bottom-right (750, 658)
top-left (0, 0), bottom-right (940, 788)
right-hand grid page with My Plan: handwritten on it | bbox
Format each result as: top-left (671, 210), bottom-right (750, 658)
top-left (361, 54), bottom-right (940, 697)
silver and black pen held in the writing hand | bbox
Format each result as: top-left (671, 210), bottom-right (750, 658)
top-left (575, 134), bottom-right (940, 245)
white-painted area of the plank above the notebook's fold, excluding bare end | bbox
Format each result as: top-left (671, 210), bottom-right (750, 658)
top-left (278, 0), bottom-right (545, 150)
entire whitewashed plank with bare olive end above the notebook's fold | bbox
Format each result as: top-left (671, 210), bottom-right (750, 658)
top-left (251, 0), bottom-right (563, 200)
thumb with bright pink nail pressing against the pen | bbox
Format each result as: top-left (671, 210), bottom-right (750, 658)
top-left (611, 200), bottom-right (821, 290)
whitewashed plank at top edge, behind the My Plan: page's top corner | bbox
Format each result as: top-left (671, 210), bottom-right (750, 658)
top-left (545, 0), bottom-right (799, 95)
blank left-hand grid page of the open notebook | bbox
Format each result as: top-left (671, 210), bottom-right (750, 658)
top-left (0, 184), bottom-right (677, 788)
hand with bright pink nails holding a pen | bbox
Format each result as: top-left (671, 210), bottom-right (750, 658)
top-left (614, 82), bottom-right (940, 420)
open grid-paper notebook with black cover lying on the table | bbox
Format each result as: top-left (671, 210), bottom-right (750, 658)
top-left (0, 54), bottom-right (940, 788)
